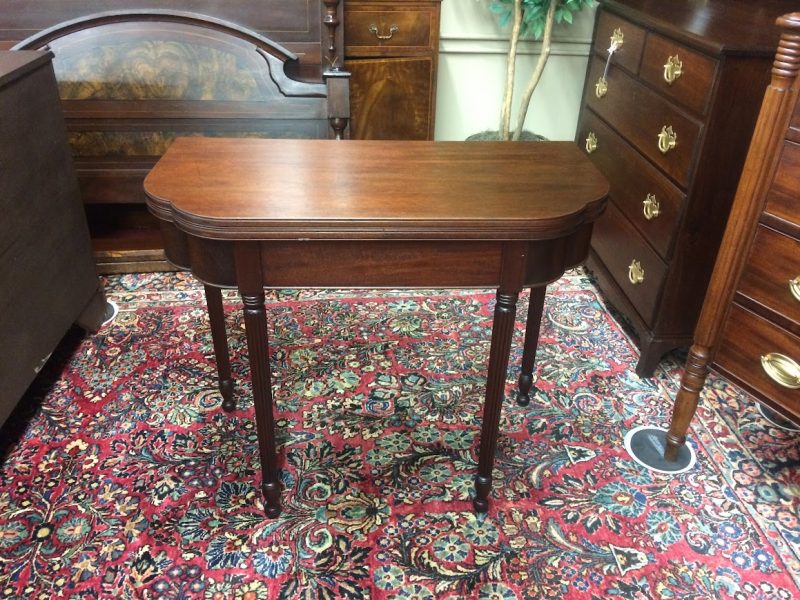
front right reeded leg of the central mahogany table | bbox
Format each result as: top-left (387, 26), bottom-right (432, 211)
top-left (472, 291), bottom-right (519, 512)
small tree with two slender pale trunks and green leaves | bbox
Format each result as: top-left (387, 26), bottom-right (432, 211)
top-left (470, 0), bottom-right (595, 140)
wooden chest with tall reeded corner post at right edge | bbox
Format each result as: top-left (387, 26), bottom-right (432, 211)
top-left (664, 13), bottom-right (800, 460)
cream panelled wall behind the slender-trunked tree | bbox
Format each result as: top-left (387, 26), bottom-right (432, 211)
top-left (435, 0), bottom-right (594, 140)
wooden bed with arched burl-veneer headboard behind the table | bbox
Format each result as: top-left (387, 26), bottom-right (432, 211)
top-left (0, 0), bottom-right (349, 272)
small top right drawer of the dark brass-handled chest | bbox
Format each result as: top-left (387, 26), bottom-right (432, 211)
top-left (639, 33), bottom-right (717, 114)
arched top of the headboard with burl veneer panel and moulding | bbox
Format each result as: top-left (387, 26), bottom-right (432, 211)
top-left (15, 10), bottom-right (326, 101)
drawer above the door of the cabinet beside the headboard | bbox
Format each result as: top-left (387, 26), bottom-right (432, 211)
top-left (344, 3), bottom-right (438, 56)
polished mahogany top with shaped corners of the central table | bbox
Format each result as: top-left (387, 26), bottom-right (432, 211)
top-left (144, 137), bottom-right (608, 240)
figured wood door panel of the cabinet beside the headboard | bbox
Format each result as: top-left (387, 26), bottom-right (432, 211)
top-left (345, 58), bottom-right (434, 140)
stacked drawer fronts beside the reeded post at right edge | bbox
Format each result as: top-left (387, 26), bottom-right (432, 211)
top-left (714, 132), bottom-right (800, 420)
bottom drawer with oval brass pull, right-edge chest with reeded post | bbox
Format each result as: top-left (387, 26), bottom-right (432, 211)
top-left (715, 304), bottom-right (800, 417)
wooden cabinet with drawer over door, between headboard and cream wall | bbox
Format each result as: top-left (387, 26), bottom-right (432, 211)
top-left (344, 0), bottom-right (441, 140)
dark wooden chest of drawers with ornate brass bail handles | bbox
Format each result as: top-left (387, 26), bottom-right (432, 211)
top-left (577, 0), bottom-right (793, 376)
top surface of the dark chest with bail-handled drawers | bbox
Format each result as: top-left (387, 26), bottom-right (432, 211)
top-left (601, 0), bottom-right (798, 57)
